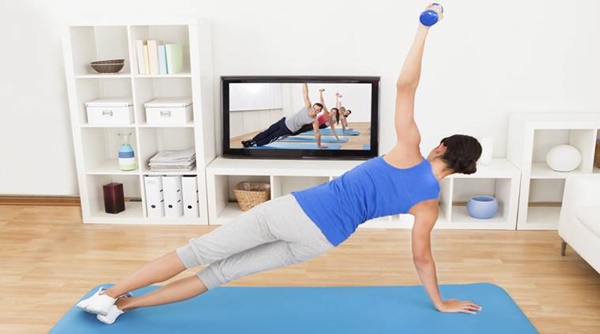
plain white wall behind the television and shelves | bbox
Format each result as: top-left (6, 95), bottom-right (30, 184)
top-left (0, 0), bottom-right (600, 195)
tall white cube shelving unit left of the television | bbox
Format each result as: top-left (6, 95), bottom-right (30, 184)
top-left (63, 19), bottom-right (215, 224)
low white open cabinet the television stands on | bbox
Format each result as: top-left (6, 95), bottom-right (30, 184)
top-left (206, 158), bottom-right (520, 229)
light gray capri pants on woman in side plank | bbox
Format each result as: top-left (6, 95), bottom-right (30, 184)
top-left (177, 195), bottom-right (334, 289)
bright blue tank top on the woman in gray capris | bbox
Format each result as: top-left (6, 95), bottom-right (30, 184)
top-left (292, 157), bottom-right (440, 246)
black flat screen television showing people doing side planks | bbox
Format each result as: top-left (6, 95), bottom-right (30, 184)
top-left (221, 76), bottom-right (380, 160)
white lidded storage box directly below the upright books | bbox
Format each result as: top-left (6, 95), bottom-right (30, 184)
top-left (144, 97), bottom-right (192, 125)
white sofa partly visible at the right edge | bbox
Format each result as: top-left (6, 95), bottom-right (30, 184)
top-left (558, 174), bottom-right (600, 273)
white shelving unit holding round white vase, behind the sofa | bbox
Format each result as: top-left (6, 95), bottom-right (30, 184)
top-left (508, 113), bottom-right (600, 230)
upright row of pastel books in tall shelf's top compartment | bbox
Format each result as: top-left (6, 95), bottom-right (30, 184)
top-left (135, 39), bottom-right (183, 74)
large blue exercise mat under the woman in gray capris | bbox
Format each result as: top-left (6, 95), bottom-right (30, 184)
top-left (50, 283), bottom-right (537, 334)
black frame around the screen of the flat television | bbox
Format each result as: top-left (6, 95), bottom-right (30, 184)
top-left (221, 75), bottom-right (381, 160)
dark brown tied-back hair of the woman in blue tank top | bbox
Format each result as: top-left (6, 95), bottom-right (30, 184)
top-left (441, 135), bottom-right (482, 174)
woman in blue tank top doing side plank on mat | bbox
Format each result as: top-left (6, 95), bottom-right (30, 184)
top-left (78, 6), bottom-right (481, 324)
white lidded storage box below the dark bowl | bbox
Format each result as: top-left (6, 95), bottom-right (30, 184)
top-left (85, 98), bottom-right (133, 125)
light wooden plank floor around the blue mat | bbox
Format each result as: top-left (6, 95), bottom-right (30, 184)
top-left (0, 206), bottom-right (600, 334)
